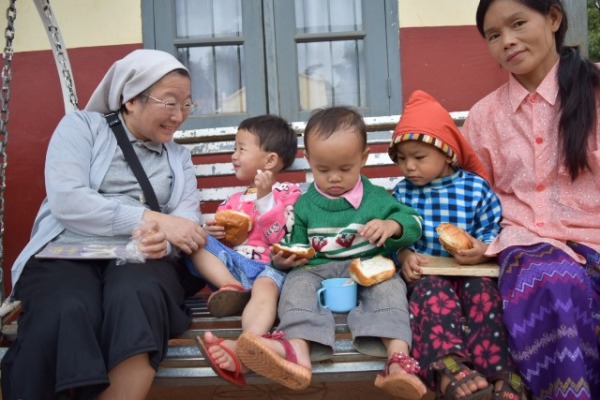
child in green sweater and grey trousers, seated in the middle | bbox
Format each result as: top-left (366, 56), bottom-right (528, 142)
top-left (237, 107), bottom-right (426, 399)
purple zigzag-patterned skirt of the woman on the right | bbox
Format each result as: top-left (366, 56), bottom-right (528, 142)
top-left (499, 243), bottom-right (600, 400)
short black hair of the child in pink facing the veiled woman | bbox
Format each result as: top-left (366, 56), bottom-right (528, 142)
top-left (238, 115), bottom-right (298, 169)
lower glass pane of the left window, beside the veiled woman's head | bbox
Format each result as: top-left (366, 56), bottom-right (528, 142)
top-left (179, 46), bottom-right (246, 115)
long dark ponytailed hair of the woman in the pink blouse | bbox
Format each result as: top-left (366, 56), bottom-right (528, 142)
top-left (476, 0), bottom-right (600, 180)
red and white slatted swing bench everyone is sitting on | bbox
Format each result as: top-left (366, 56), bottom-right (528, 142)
top-left (0, 112), bottom-right (496, 394)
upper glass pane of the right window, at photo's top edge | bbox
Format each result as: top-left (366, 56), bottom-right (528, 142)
top-left (295, 0), bottom-right (363, 33)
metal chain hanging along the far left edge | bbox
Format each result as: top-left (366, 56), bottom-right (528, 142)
top-left (0, 0), bottom-right (17, 299)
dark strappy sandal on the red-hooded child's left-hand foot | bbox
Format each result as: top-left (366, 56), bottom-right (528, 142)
top-left (433, 356), bottom-right (494, 400)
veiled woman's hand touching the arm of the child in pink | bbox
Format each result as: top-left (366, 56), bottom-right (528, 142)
top-left (143, 210), bottom-right (206, 254)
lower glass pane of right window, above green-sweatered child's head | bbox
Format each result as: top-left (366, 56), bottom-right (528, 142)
top-left (297, 40), bottom-right (366, 110)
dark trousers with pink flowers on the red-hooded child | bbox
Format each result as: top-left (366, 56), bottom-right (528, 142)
top-left (409, 276), bottom-right (514, 389)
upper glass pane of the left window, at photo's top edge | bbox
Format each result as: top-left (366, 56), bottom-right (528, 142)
top-left (176, 0), bottom-right (242, 38)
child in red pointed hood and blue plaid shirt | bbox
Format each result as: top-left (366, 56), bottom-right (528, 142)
top-left (389, 91), bottom-right (522, 399)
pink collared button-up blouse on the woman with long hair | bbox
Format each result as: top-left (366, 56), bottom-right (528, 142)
top-left (463, 63), bottom-right (600, 263)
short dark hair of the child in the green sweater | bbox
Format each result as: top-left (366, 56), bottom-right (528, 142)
top-left (304, 106), bottom-right (367, 152)
